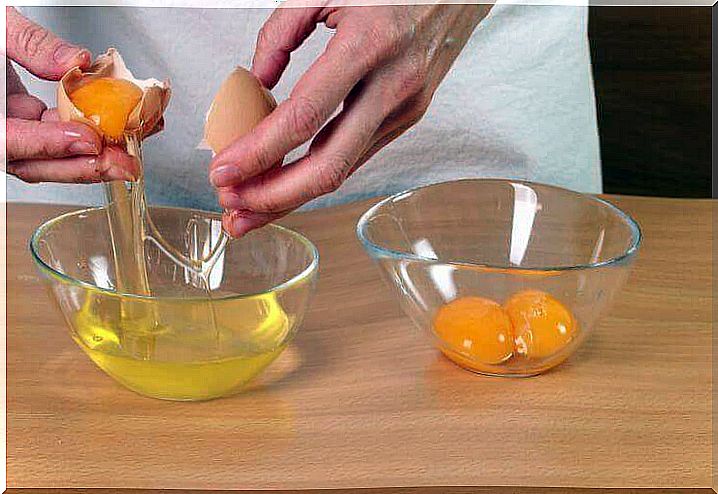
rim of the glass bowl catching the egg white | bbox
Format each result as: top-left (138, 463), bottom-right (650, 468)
top-left (29, 206), bottom-right (319, 302)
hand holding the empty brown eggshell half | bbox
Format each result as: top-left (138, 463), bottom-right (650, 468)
top-left (210, 5), bottom-right (490, 236)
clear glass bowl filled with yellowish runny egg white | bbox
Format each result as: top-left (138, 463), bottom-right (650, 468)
top-left (30, 207), bottom-right (319, 401)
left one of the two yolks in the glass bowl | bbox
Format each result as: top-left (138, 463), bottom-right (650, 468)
top-left (434, 297), bottom-right (513, 368)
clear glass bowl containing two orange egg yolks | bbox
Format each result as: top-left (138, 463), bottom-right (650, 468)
top-left (357, 179), bottom-right (641, 376)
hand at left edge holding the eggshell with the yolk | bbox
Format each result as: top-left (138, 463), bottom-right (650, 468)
top-left (5, 7), bottom-right (139, 183)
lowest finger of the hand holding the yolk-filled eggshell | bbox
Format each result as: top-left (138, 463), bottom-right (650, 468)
top-left (7, 147), bottom-right (140, 183)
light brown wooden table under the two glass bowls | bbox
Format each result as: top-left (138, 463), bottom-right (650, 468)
top-left (7, 197), bottom-right (712, 494)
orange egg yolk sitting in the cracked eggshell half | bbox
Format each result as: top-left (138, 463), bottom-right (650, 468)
top-left (70, 77), bottom-right (142, 140)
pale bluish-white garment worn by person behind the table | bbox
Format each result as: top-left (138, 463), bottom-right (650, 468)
top-left (7, 4), bottom-right (601, 209)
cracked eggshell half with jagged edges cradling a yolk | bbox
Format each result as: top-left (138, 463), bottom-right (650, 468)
top-left (57, 48), bottom-right (171, 139)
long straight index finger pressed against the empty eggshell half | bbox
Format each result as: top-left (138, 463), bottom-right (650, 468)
top-left (210, 24), bottom-right (394, 191)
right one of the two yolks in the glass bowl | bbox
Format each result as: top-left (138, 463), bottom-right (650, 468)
top-left (505, 290), bottom-right (576, 358)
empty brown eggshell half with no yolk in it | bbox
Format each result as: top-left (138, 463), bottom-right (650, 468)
top-left (200, 67), bottom-right (277, 153)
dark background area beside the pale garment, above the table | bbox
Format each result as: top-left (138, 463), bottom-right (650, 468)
top-left (588, 7), bottom-right (711, 197)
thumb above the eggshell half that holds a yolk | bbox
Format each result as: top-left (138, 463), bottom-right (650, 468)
top-left (6, 7), bottom-right (92, 81)
